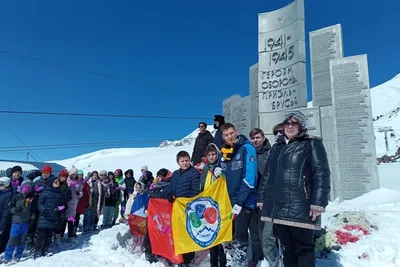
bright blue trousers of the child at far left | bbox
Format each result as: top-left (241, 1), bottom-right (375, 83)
top-left (4, 222), bottom-right (29, 261)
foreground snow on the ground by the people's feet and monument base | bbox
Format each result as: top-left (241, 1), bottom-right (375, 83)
top-left (7, 170), bottom-right (400, 267)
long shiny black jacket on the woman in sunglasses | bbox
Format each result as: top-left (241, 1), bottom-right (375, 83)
top-left (260, 132), bottom-right (330, 230)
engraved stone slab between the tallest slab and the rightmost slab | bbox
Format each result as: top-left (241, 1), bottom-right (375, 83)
top-left (310, 24), bottom-right (343, 107)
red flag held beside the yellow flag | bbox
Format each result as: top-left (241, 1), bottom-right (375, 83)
top-left (147, 198), bottom-right (183, 264)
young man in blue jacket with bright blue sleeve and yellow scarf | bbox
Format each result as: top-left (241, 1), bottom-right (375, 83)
top-left (221, 123), bottom-right (257, 267)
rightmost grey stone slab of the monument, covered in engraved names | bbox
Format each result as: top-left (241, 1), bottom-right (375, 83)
top-left (330, 55), bottom-right (379, 201)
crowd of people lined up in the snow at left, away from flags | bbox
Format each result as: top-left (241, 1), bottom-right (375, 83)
top-left (0, 165), bottom-right (154, 263)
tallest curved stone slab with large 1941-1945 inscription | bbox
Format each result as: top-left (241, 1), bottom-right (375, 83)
top-left (258, 0), bottom-right (307, 134)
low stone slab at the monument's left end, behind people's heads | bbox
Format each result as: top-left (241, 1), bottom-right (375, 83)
top-left (223, 94), bottom-right (251, 136)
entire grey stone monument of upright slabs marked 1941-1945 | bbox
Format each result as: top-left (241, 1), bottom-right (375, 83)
top-left (223, 0), bottom-right (379, 201)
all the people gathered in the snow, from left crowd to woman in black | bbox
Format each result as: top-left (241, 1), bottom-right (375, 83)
top-left (0, 110), bottom-right (330, 267)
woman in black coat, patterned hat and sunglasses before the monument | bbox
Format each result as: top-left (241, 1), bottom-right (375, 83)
top-left (260, 110), bottom-right (330, 267)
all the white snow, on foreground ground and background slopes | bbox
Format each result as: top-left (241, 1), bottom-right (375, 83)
top-left (4, 75), bottom-right (400, 267)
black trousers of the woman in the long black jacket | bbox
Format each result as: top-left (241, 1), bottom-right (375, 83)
top-left (274, 224), bottom-right (316, 267)
